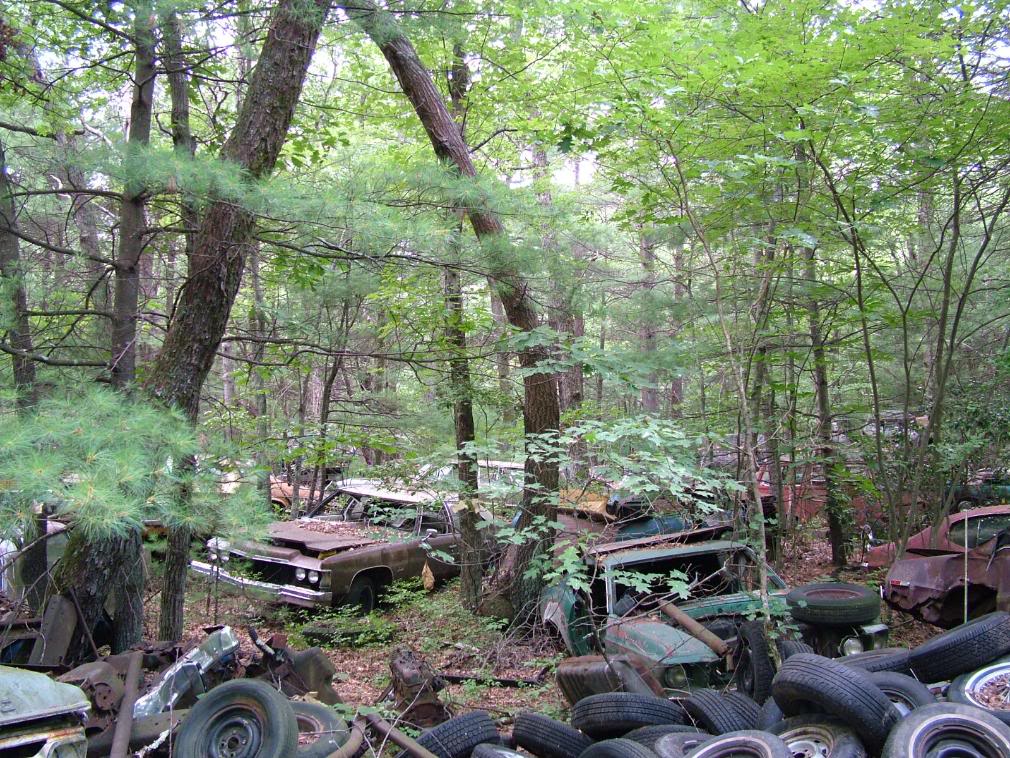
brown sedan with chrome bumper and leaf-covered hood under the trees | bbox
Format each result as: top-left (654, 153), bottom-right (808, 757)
top-left (190, 479), bottom-right (460, 611)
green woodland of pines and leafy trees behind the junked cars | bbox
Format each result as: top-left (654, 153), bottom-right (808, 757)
top-left (0, 0), bottom-right (1010, 755)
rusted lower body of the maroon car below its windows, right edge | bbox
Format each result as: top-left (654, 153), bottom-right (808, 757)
top-left (883, 544), bottom-right (1010, 628)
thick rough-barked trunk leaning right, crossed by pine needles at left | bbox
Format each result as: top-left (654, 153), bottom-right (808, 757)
top-left (145, 0), bottom-right (330, 640)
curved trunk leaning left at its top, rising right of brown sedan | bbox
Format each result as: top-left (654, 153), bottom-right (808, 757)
top-left (340, 0), bottom-right (560, 618)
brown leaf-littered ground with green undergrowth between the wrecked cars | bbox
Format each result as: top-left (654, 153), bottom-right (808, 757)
top-left (147, 537), bottom-right (939, 722)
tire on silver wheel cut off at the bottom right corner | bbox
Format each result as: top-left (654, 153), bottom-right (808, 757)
top-left (881, 702), bottom-right (1010, 758)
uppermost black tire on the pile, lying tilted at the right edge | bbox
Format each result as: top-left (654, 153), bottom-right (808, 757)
top-left (910, 610), bottom-right (1010, 684)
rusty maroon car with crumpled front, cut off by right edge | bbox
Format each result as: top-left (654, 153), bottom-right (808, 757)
top-left (882, 505), bottom-right (1010, 629)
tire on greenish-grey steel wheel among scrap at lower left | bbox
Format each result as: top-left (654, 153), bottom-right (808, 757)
top-left (175, 679), bottom-right (298, 758)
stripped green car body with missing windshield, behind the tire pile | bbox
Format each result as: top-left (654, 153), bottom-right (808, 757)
top-left (540, 528), bottom-right (888, 691)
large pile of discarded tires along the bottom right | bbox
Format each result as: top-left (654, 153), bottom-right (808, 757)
top-left (406, 612), bottom-right (1010, 758)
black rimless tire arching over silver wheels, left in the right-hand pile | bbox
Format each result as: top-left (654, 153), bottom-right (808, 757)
top-left (772, 654), bottom-right (901, 751)
